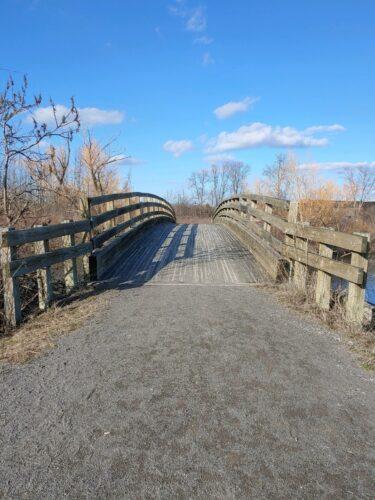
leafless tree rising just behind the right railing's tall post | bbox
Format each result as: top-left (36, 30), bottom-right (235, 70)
top-left (263, 154), bottom-right (296, 199)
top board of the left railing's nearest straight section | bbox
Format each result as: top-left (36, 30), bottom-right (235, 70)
top-left (4, 220), bottom-right (90, 246)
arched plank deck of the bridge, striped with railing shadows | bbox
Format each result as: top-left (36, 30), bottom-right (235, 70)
top-left (111, 222), bottom-right (268, 285)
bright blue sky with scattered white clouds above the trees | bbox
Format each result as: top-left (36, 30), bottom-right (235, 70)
top-left (0, 0), bottom-right (375, 194)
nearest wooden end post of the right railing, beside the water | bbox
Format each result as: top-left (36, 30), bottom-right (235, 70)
top-left (346, 233), bottom-right (370, 324)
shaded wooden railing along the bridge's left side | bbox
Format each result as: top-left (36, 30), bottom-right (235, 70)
top-left (1, 192), bottom-right (175, 326)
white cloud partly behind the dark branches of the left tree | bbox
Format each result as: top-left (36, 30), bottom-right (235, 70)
top-left (29, 104), bottom-right (124, 127)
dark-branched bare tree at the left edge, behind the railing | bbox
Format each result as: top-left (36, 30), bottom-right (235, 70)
top-left (0, 77), bottom-right (79, 225)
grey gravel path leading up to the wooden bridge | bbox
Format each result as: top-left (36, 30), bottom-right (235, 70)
top-left (0, 225), bottom-right (375, 499)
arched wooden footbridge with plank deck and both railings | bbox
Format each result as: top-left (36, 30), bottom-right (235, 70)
top-left (1, 189), bottom-right (369, 326)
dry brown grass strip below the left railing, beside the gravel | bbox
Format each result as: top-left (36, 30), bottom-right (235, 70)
top-left (0, 292), bottom-right (106, 363)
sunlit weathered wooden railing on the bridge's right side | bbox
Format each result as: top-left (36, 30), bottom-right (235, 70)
top-left (214, 193), bottom-right (370, 323)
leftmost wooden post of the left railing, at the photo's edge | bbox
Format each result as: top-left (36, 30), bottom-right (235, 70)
top-left (1, 227), bottom-right (22, 327)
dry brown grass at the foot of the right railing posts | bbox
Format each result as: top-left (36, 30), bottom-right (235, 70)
top-left (272, 281), bottom-right (375, 371)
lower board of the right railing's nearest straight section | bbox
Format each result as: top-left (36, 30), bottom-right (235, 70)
top-left (283, 245), bottom-right (363, 285)
